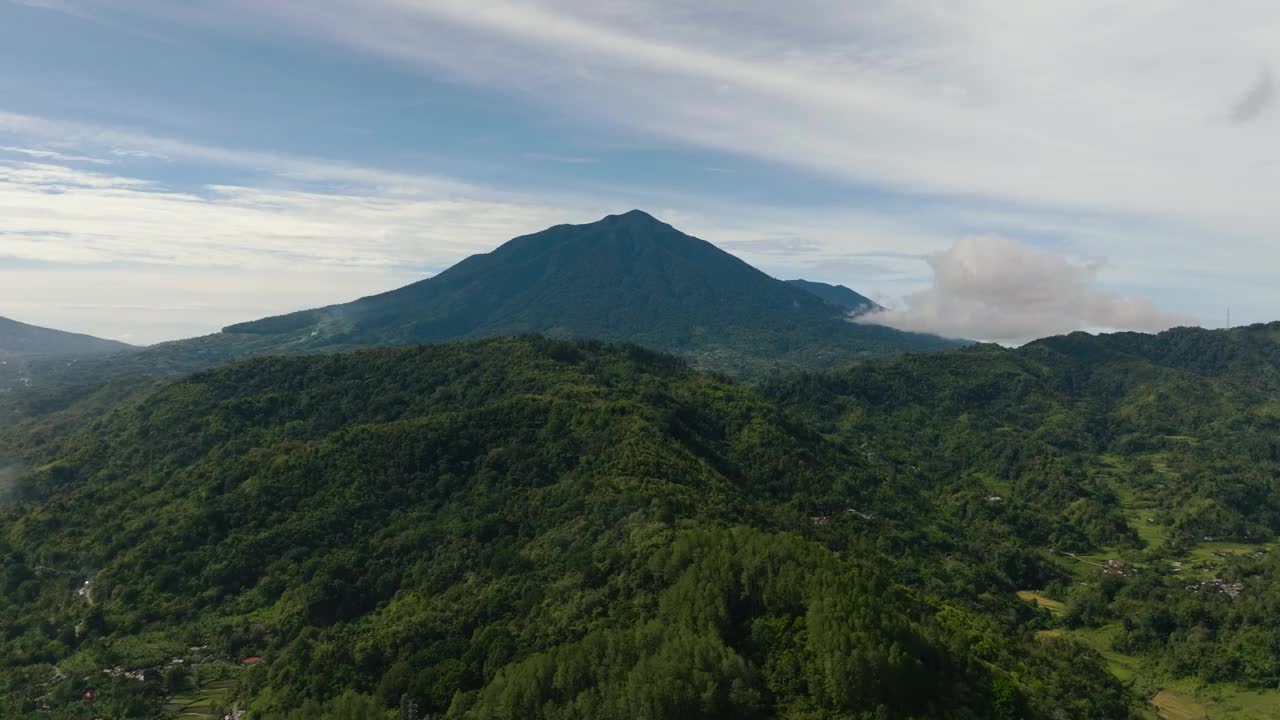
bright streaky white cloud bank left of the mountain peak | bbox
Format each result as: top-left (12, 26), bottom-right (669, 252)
top-left (0, 161), bottom-right (594, 270)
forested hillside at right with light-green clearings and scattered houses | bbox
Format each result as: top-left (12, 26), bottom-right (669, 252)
top-left (764, 319), bottom-right (1280, 717)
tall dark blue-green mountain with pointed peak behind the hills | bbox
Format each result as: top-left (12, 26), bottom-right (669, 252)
top-left (223, 210), bottom-right (955, 372)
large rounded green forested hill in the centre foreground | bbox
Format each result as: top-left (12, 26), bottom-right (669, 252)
top-left (0, 338), bottom-right (1133, 720)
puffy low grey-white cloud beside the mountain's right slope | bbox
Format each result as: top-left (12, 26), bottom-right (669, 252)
top-left (864, 237), bottom-right (1197, 342)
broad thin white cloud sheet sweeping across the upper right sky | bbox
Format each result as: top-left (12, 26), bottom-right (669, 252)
top-left (129, 0), bottom-right (1280, 280)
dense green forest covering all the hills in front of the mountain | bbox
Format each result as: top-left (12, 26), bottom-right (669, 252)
top-left (0, 325), bottom-right (1280, 720)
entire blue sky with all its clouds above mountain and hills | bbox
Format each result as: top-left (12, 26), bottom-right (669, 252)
top-left (0, 0), bottom-right (1280, 343)
